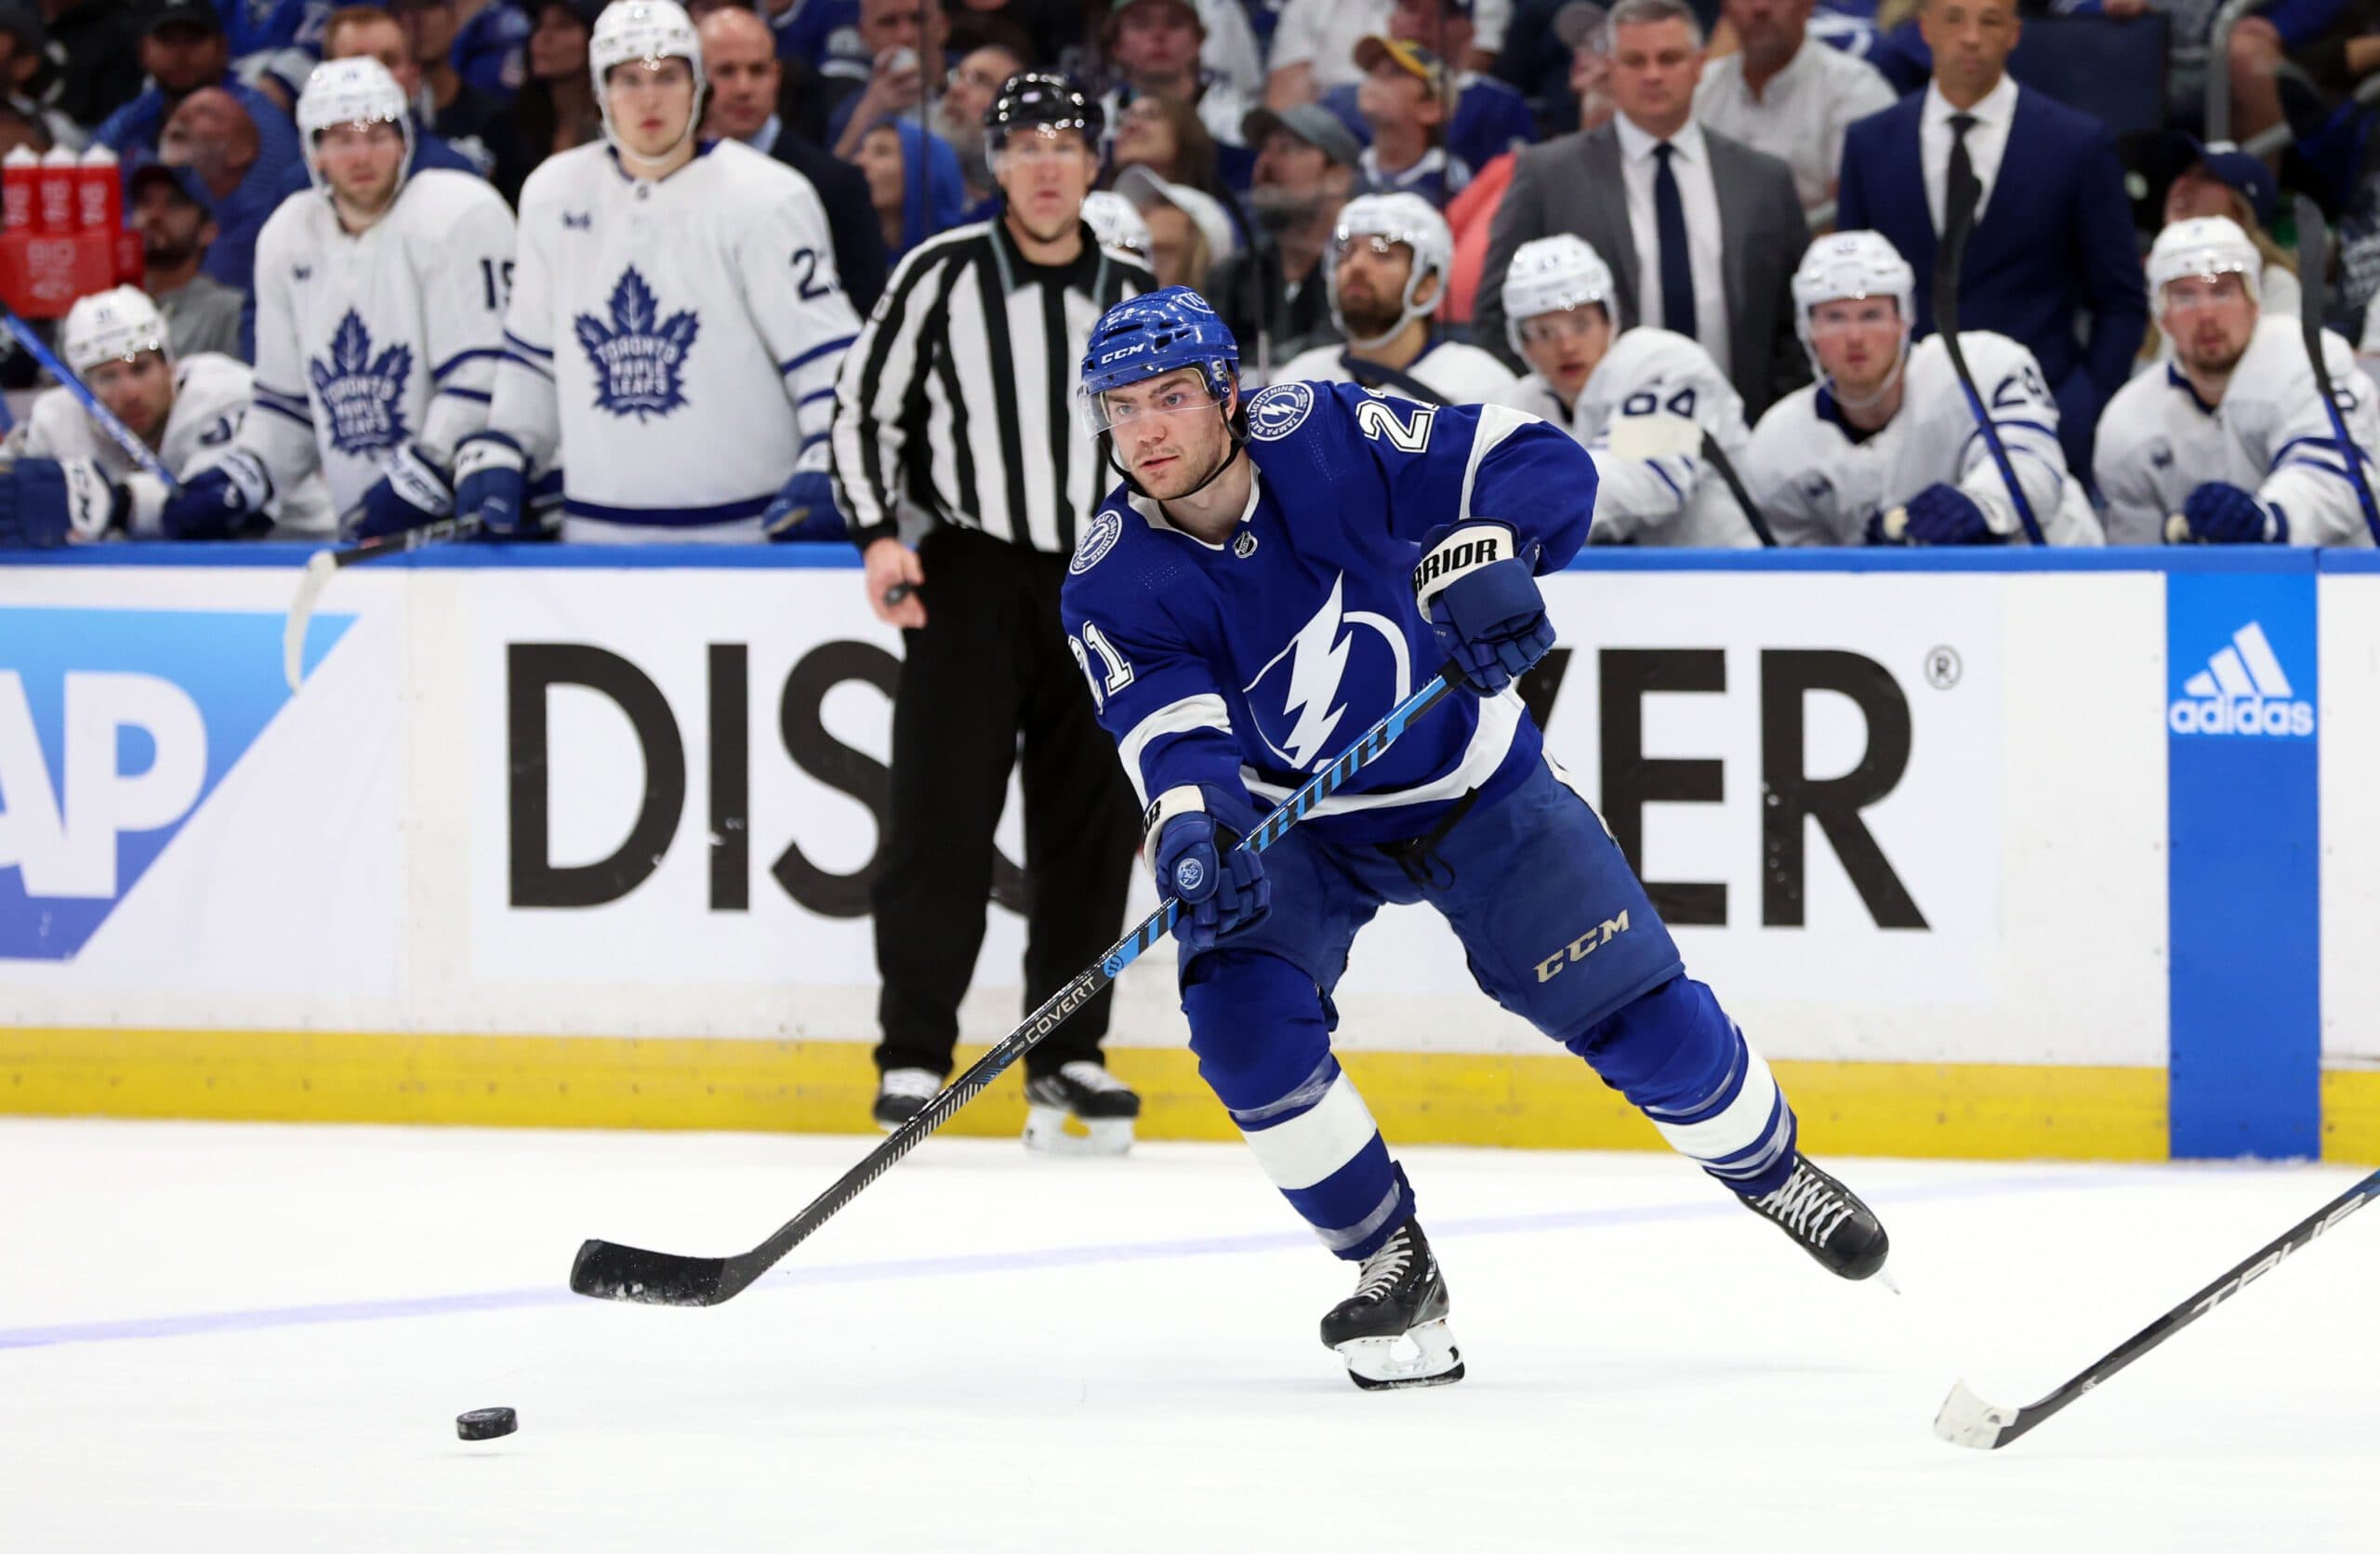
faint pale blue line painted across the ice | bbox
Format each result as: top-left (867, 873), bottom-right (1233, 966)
top-left (0, 1171), bottom-right (2128, 1349)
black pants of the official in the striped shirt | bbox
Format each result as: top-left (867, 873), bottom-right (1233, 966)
top-left (874, 526), bottom-right (1140, 1076)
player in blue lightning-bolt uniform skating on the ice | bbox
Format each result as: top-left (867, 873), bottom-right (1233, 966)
top-left (1064, 286), bottom-right (1887, 1388)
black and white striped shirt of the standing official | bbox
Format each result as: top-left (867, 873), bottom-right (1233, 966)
top-left (833, 219), bottom-right (1157, 554)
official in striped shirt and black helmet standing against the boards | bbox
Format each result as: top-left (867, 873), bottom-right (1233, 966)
top-left (833, 73), bottom-right (1157, 1152)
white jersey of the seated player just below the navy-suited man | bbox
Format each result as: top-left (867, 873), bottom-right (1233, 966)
top-left (1739, 331), bottom-right (2104, 545)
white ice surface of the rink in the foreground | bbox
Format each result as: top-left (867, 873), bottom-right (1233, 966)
top-left (0, 1121), bottom-right (2380, 1554)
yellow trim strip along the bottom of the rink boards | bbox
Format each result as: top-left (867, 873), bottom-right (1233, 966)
top-left (0, 1028), bottom-right (2179, 1159)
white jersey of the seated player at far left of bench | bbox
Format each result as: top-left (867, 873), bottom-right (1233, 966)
top-left (9, 350), bottom-right (338, 540)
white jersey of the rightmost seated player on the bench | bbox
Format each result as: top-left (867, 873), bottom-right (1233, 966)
top-left (2092, 316), bottom-right (2380, 545)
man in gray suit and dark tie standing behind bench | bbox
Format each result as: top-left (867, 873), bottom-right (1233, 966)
top-left (1475, 0), bottom-right (1809, 421)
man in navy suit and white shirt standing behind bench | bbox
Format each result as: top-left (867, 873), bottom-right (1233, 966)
top-left (1835, 0), bottom-right (2149, 469)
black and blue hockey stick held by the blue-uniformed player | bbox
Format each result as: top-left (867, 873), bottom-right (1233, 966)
top-left (571, 673), bottom-right (1452, 1307)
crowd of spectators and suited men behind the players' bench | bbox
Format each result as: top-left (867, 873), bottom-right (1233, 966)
top-left (0, 0), bottom-right (2380, 545)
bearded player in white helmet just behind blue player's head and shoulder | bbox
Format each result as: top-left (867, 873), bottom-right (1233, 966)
top-left (1276, 195), bottom-right (1514, 405)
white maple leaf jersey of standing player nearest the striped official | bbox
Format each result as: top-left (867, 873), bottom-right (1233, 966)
top-left (488, 140), bottom-right (859, 542)
